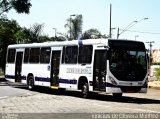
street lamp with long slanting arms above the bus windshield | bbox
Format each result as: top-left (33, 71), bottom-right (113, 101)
top-left (117, 18), bottom-right (148, 39)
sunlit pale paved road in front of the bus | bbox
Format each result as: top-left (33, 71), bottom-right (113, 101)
top-left (0, 82), bottom-right (160, 118)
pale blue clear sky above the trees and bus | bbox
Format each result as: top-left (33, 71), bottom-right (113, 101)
top-left (6, 0), bottom-right (160, 49)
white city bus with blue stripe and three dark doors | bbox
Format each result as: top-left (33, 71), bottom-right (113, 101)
top-left (5, 39), bottom-right (148, 98)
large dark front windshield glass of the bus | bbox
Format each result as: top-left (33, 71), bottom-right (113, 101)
top-left (110, 42), bottom-right (147, 81)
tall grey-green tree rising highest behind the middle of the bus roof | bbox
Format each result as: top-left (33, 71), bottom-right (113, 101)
top-left (65, 15), bottom-right (83, 40)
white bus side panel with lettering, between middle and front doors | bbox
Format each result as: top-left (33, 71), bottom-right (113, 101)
top-left (59, 64), bottom-right (93, 91)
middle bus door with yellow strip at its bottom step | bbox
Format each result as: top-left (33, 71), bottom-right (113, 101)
top-left (51, 47), bottom-right (61, 89)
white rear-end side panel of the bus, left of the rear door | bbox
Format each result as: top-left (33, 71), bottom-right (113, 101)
top-left (5, 63), bottom-right (15, 82)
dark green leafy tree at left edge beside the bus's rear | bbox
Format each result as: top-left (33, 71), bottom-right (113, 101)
top-left (0, 17), bottom-right (20, 69)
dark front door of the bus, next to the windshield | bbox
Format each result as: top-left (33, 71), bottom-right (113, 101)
top-left (93, 50), bottom-right (107, 91)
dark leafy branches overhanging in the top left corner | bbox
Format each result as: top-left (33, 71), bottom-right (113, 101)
top-left (0, 0), bottom-right (32, 15)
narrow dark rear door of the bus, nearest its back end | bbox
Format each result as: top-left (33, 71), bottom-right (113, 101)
top-left (15, 50), bottom-right (23, 82)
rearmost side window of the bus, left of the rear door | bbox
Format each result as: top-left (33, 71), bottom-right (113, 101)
top-left (7, 49), bottom-right (16, 63)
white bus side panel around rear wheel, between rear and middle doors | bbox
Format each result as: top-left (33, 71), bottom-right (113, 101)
top-left (22, 64), bottom-right (50, 87)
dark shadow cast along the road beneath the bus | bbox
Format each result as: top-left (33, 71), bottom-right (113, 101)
top-left (10, 83), bottom-right (160, 104)
